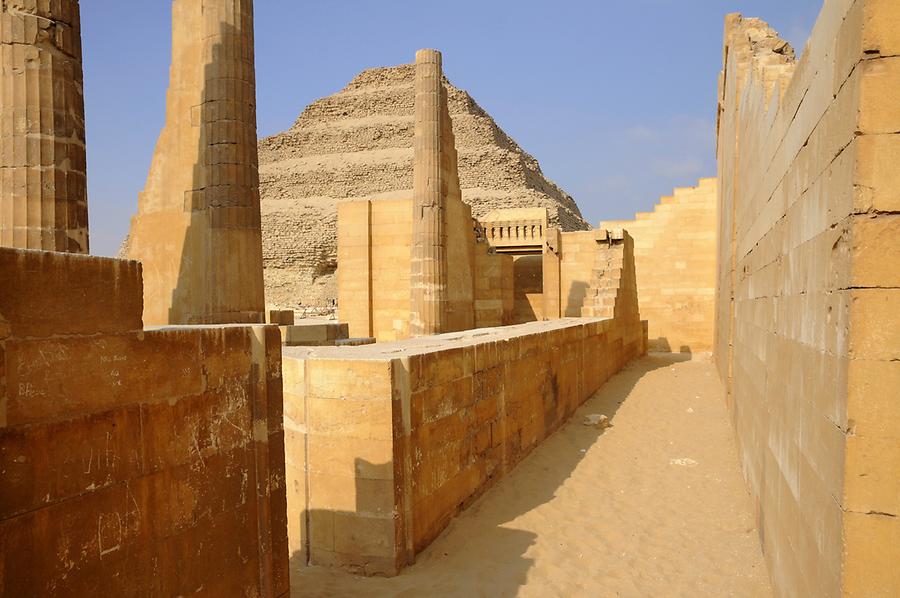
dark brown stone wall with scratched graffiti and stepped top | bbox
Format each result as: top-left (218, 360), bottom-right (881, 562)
top-left (0, 249), bottom-right (289, 596)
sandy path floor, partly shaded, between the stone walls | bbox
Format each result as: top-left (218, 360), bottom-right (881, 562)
top-left (292, 354), bottom-right (772, 598)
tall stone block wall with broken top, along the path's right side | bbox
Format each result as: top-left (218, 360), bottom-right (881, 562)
top-left (715, 0), bottom-right (900, 596)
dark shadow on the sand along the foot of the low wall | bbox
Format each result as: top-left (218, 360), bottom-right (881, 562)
top-left (291, 354), bottom-right (690, 597)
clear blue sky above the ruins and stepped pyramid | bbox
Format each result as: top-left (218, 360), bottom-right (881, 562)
top-left (81, 0), bottom-right (821, 255)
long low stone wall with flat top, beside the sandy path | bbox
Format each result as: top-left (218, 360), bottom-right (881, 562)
top-left (284, 318), bottom-right (646, 575)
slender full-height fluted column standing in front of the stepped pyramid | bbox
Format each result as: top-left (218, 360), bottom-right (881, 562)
top-left (410, 50), bottom-right (452, 336)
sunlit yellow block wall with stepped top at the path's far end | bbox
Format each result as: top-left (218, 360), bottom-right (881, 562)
top-left (599, 179), bottom-right (718, 352)
